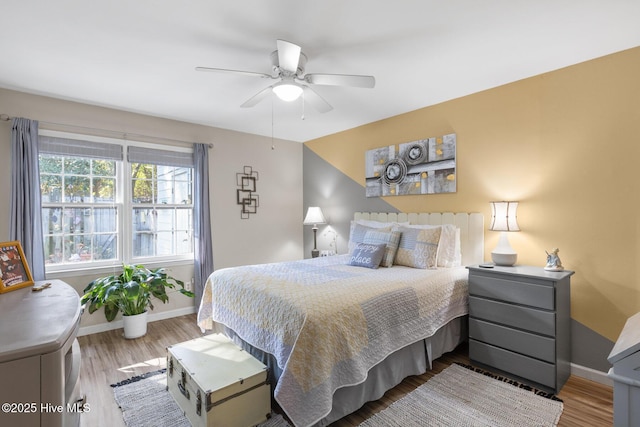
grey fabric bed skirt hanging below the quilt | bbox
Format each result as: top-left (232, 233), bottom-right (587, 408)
top-left (214, 316), bottom-right (467, 427)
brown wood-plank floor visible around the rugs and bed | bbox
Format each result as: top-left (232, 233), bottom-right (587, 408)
top-left (78, 315), bottom-right (613, 427)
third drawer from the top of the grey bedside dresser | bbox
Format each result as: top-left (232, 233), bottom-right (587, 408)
top-left (469, 319), bottom-right (556, 363)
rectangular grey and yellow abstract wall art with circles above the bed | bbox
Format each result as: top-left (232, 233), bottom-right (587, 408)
top-left (365, 133), bottom-right (456, 197)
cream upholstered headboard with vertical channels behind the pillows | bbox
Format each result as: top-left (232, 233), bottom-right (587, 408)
top-left (353, 212), bottom-right (484, 265)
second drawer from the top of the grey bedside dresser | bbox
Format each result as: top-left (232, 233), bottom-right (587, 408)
top-left (469, 296), bottom-right (556, 337)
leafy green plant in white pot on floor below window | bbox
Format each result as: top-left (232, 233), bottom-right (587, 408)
top-left (80, 264), bottom-right (194, 339)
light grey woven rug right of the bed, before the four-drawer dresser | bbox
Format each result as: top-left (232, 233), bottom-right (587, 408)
top-left (361, 364), bottom-right (563, 427)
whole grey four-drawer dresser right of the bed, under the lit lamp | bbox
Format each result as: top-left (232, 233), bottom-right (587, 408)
top-left (469, 266), bottom-right (573, 393)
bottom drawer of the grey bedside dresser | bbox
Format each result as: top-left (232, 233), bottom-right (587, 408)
top-left (469, 339), bottom-right (556, 390)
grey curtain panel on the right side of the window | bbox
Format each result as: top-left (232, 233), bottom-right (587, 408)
top-left (193, 144), bottom-right (213, 304)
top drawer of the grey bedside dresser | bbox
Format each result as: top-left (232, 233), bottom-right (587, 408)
top-left (469, 274), bottom-right (555, 310)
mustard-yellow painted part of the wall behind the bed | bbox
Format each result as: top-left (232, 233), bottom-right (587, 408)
top-left (306, 47), bottom-right (640, 341)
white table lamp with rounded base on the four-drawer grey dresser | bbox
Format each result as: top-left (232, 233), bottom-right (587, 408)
top-left (489, 202), bottom-right (520, 266)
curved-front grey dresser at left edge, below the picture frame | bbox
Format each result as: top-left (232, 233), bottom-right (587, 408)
top-left (0, 280), bottom-right (86, 427)
